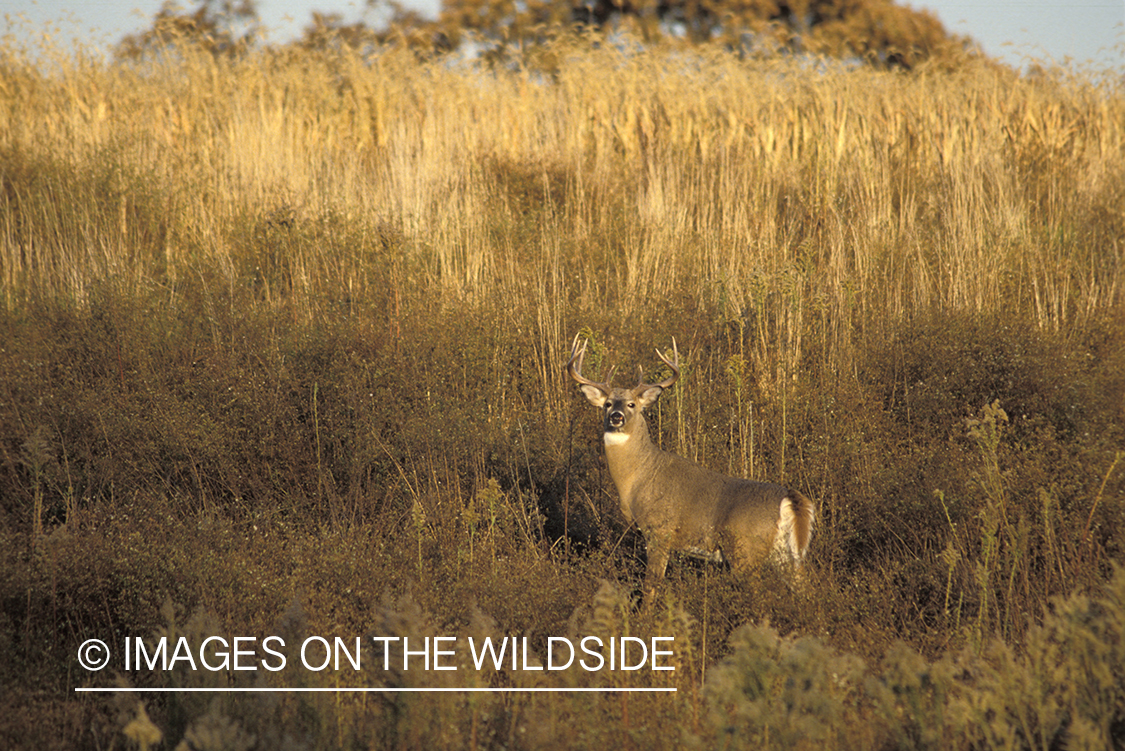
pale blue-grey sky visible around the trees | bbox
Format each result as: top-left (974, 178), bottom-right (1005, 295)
top-left (0, 0), bottom-right (1125, 70)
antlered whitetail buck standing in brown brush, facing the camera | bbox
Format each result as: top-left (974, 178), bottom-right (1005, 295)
top-left (566, 336), bottom-right (816, 592)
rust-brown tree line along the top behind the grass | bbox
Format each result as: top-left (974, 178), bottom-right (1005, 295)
top-left (116, 0), bottom-right (973, 69)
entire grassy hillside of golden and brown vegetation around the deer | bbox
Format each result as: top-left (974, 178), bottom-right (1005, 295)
top-left (0, 33), bottom-right (1125, 749)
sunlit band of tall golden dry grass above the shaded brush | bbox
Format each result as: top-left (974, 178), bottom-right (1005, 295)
top-left (0, 35), bottom-right (1125, 376)
